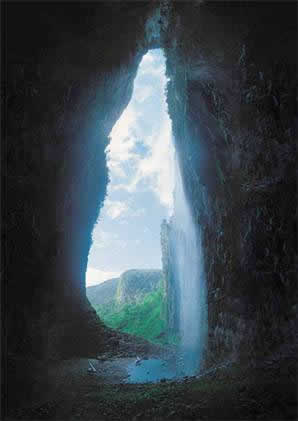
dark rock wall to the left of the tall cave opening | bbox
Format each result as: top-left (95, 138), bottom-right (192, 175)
top-left (2, 2), bottom-right (154, 357)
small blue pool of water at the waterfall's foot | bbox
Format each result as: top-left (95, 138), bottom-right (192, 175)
top-left (126, 358), bottom-right (182, 383)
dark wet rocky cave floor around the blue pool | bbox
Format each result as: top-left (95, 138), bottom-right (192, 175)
top-left (7, 335), bottom-right (298, 421)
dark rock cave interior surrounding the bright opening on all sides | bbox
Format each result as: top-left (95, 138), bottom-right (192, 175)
top-left (1, 0), bottom-right (298, 419)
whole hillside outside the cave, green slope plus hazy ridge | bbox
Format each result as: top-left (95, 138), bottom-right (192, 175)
top-left (87, 269), bottom-right (175, 344)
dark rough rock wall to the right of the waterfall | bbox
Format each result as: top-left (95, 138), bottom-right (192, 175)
top-left (164, 1), bottom-right (297, 363)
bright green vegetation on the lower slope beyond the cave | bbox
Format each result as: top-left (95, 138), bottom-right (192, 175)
top-left (95, 287), bottom-right (176, 344)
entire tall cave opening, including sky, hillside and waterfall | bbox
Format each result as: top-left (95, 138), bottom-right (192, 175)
top-left (86, 48), bottom-right (207, 381)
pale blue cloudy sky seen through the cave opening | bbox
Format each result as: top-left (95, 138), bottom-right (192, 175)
top-left (86, 49), bottom-right (174, 286)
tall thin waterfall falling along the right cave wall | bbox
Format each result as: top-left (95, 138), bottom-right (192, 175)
top-left (170, 157), bottom-right (207, 375)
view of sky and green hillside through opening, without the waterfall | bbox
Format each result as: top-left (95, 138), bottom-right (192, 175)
top-left (86, 48), bottom-right (175, 344)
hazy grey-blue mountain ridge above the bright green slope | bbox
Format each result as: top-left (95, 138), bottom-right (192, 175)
top-left (86, 269), bottom-right (163, 307)
